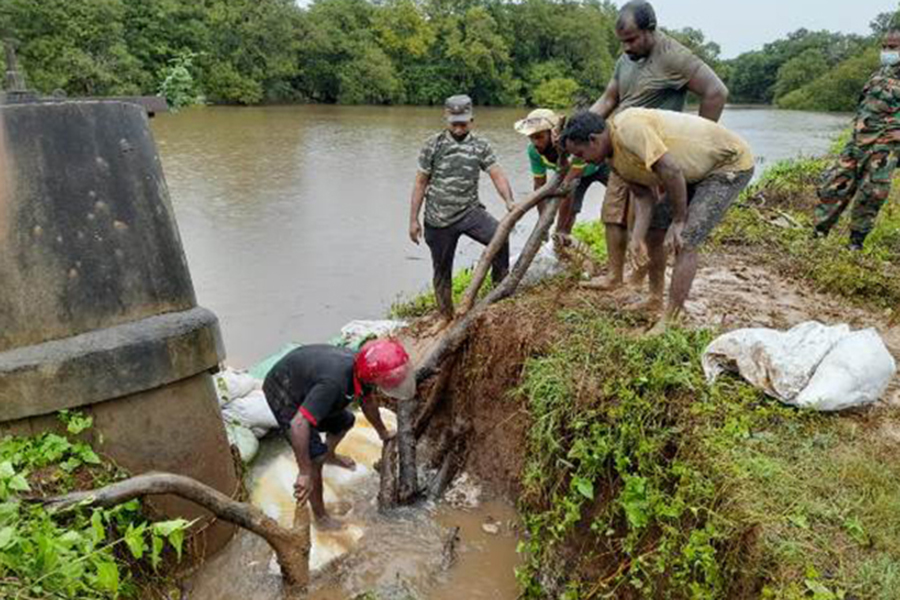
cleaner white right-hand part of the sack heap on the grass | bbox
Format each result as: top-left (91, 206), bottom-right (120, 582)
top-left (794, 329), bottom-right (897, 411)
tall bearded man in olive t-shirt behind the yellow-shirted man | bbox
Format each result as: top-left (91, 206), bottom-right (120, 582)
top-left (589, 0), bottom-right (728, 302)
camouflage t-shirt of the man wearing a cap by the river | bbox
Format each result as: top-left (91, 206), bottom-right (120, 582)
top-left (419, 130), bottom-right (497, 228)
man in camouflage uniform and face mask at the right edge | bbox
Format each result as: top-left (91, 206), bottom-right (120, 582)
top-left (815, 28), bottom-right (900, 250)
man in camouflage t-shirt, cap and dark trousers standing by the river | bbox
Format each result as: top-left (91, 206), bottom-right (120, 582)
top-left (409, 95), bottom-right (514, 324)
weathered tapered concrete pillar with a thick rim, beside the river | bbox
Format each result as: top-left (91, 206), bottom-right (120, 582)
top-left (0, 102), bottom-right (239, 552)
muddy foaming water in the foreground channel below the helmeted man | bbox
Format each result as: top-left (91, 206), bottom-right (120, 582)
top-left (189, 415), bottom-right (518, 600)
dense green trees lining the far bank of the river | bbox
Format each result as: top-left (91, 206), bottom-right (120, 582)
top-left (0, 0), bottom-right (892, 110)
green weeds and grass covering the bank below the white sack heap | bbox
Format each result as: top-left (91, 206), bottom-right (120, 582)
top-left (518, 311), bottom-right (900, 600)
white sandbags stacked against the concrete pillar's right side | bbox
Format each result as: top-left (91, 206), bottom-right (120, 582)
top-left (215, 367), bottom-right (278, 463)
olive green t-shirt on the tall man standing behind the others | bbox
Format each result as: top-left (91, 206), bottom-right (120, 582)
top-left (613, 31), bottom-right (703, 112)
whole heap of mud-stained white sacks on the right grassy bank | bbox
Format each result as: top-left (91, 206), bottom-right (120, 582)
top-left (703, 321), bottom-right (897, 411)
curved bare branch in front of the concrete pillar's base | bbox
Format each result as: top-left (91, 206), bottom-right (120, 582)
top-left (37, 473), bottom-right (310, 600)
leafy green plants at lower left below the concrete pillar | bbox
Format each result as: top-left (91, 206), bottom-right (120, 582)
top-left (0, 411), bottom-right (189, 599)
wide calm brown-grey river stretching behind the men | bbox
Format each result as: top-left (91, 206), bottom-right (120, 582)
top-left (152, 106), bottom-right (848, 366)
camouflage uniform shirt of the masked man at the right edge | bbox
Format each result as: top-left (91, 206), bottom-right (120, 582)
top-left (853, 66), bottom-right (900, 147)
